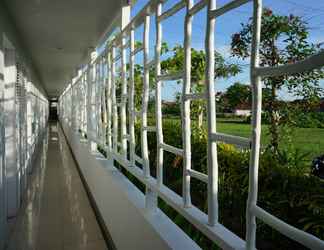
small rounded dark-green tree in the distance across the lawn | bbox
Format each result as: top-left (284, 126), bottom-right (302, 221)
top-left (224, 82), bottom-right (252, 110)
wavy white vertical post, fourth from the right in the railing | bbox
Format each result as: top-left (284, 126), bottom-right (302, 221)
top-left (155, 2), bottom-right (163, 186)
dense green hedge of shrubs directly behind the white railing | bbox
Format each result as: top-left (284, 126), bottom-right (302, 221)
top-left (132, 119), bottom-right (324, 249)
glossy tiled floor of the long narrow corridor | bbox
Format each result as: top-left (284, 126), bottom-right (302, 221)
top-left (7, 124), bottom-right (107, 250)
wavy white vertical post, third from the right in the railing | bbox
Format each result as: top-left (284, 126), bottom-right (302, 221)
top-left (181, 0), bottom-right (193, 207)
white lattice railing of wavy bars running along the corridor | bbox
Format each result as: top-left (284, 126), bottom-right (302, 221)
top-left (59, 0), bottom-right (324, 249)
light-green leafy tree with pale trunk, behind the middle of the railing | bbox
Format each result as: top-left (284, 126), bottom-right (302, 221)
top-left (161, 45), bottom-right (241, 127)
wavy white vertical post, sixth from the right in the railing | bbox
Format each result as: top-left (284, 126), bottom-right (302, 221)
top-left (128, 29), bottom-right (135, 166)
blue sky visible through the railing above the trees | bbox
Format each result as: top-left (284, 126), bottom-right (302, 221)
top-left (111, 0), bottom-right (324, 100)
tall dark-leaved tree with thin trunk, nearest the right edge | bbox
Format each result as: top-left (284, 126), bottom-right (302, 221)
top-left (231, 8), bottom-right (323, 155)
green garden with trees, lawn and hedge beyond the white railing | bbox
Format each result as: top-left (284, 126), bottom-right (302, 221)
top-left (96, 6), bottom-right (324, 249)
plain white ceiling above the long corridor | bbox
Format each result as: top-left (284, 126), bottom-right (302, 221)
top-left (5, 0), bottom-right (126, 96)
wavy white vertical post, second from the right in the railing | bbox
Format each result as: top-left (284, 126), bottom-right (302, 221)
top-left (205, 0), bottom-right (218, 226)
